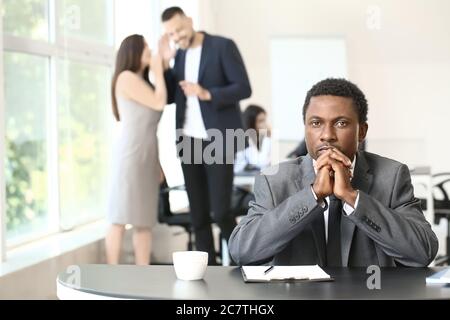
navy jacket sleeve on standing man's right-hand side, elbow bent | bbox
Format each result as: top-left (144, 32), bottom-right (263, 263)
top-left (207, 39), bottom-right (252, 108)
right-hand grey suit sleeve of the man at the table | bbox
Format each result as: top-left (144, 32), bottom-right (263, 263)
top-left (347, 165), bottom-right (438, 267)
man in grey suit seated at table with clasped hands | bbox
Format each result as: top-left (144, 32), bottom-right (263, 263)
top-left (229, 79), bottom-right (438, 267)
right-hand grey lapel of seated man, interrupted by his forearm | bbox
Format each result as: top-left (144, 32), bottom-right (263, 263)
top-left (341, 152), bottom-right (373, 267)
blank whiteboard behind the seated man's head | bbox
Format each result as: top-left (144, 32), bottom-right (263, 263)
top-left (270, 37), bottom-right (347, 141)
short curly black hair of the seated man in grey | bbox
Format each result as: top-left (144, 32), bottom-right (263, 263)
top-left (303, 78), bottom-right (368, 123)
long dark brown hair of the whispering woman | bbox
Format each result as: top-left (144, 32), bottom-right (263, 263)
top-left (111, 34), bottom-right (151, 121)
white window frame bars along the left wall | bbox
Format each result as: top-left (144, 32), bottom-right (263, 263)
top-left (0, 0), bottom-right (115, 252)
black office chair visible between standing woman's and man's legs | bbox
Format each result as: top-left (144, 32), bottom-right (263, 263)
top-left (158, 180), bottom-right (194, 251)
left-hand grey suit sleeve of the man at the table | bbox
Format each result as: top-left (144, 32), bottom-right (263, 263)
top-left (229, 175), bottom-right (324, 265)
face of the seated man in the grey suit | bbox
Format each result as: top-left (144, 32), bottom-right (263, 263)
top-left (305, 95), bottom-right (368, 160)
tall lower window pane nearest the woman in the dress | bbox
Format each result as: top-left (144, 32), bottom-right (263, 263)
top-left (58, 60), bottom-right (112, 229)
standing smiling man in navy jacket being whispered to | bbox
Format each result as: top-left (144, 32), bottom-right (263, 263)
top-left (159, 7), bottom-right (251, 264)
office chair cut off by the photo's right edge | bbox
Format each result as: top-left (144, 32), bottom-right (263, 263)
top-left (432, 172), bottom-right (450, 266)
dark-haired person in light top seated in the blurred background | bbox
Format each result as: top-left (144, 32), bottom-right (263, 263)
top-left (234, 105), bottom-right (271, 173)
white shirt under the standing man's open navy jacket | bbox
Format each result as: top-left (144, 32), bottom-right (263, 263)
top-left (183, 46), bottom-right (208, 139)
